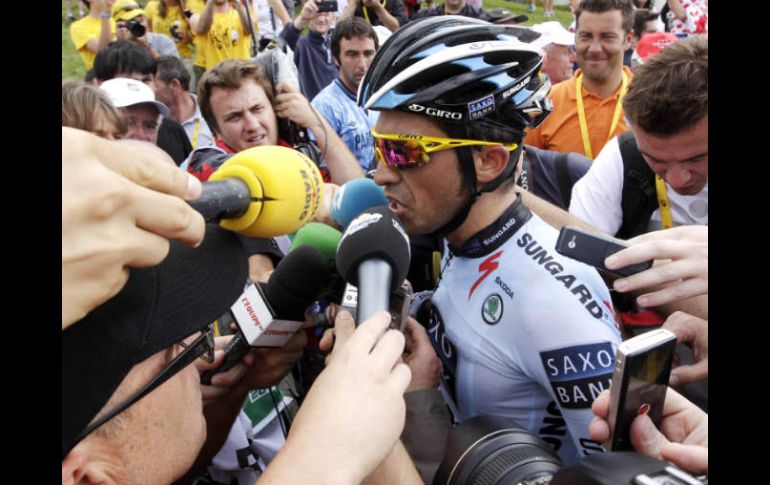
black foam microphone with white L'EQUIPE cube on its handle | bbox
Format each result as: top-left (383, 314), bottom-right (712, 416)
top-left (201, 246), bottom-right (328, 384)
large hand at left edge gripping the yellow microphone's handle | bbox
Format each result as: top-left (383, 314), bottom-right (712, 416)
top-left (61, 127), bottom-right (205, 330)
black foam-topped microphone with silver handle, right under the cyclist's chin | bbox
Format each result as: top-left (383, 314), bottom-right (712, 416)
top-left (337, 206), bottom-right (410, 323)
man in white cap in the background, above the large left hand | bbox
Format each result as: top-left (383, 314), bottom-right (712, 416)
top-left (99, 77), bottom-right (171, 145)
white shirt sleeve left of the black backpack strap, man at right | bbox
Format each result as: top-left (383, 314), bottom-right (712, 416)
top-left (569, 137), bottom-right (623, 235)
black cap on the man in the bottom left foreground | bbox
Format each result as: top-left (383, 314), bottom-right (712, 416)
top-left (61, 224), bottom-right (248, 459)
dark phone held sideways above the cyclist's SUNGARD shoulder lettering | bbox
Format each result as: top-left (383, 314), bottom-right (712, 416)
top-left (556, 226), bottom-right (652, 276)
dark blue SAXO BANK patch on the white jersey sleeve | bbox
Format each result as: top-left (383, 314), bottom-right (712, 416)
top-left (540, 342), bottom-right (615, 409)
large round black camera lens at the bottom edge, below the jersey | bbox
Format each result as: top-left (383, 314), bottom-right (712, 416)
top-left (433, 416), bottom-right (561, 485)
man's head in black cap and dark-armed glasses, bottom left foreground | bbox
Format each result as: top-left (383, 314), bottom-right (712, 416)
top-left (62, 225), bottom-right (247, 483)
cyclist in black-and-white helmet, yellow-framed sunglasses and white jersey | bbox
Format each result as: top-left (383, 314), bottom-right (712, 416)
top-left (359, 16), bottom-right (621, 463)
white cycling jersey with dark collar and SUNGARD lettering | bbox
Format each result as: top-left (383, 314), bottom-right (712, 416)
top-left (429, 199), bottom-right (621, 464)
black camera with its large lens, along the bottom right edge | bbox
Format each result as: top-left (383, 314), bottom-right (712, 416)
top-left (433, 416), bottom-right (708, 485)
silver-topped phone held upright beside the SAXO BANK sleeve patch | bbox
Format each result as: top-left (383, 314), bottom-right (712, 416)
top-left (607, 328), bottom-right (676, 451)
